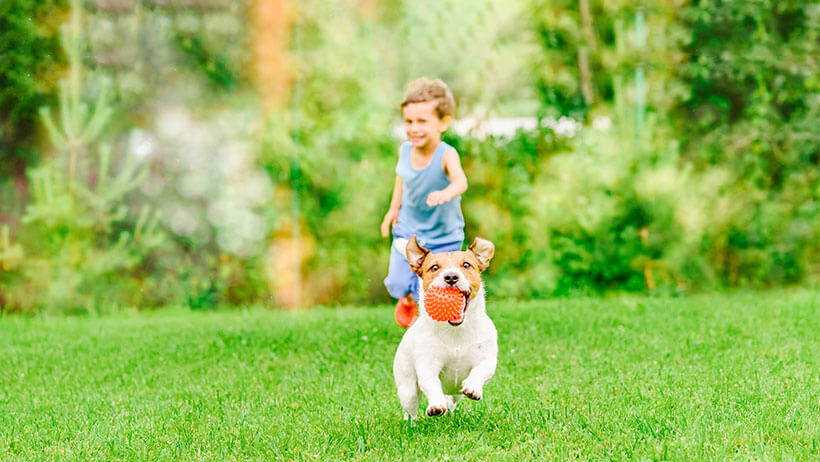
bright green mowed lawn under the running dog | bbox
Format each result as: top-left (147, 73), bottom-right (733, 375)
top-left (0, 291), bottom-right (820, 460)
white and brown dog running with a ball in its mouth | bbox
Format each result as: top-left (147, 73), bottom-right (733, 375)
top-left (393, 235), bottom-right (498, 420)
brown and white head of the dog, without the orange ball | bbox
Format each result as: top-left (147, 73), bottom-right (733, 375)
top-left (406, 235), bottom-right (495, 325)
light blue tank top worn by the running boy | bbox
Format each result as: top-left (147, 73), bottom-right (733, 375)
top-left (393, 141), bottom-right (464, 246)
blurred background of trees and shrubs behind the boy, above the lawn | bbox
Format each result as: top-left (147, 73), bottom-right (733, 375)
top-left (0, 0), bottom-right (820, 313)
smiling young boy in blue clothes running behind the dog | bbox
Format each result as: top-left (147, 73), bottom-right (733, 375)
top-left (381, 78), bottom-right (467, 327)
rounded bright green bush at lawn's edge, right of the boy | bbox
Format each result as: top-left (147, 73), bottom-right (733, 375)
top-left (523, 124), bottom-right (705, 294)
